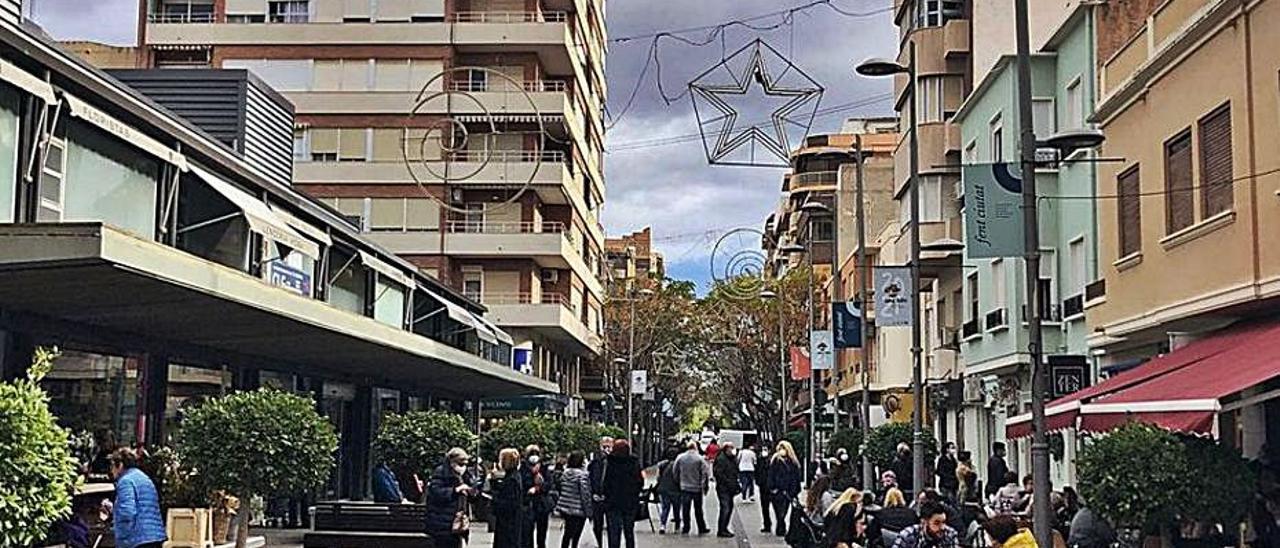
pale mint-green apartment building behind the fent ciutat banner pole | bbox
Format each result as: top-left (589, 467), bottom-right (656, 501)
top-left (938, 5), bottom-right (1098, 484)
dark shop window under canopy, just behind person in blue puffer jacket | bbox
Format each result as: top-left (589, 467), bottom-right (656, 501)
top-left (40, 350), bottom-right (140, 481)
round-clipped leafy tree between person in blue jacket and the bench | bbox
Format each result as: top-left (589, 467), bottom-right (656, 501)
top-left (178, 388), bottom-right (338, 548)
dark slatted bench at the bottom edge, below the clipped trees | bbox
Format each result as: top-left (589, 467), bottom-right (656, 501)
top-left (302, 501), bottom-right (433, 548)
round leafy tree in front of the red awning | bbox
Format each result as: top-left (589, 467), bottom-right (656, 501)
top-left (1075, 423), bottom-right (1192, 531)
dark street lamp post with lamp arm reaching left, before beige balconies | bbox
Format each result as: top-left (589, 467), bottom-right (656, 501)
top-left (856, 42), bottom-right (926, 493)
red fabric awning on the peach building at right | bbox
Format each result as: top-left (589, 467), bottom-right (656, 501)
top-left (1006, 321), bottom-right (1280, 438)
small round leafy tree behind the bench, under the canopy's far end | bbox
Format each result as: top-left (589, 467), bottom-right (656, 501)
top-left (372, 411), bottom-right (475, 478)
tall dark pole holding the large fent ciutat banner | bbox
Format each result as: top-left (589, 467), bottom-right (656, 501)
top-left (1014, 0), bottom-right (1053, 547)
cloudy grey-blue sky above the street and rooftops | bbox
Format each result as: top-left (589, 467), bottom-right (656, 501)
top-left (27, 0), bottom-right (896, 289)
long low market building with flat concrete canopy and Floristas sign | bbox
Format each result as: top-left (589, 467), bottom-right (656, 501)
top-left (0, 6), bottom-right (558, 498)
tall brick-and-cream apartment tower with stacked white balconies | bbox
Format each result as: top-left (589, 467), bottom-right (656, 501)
top-left (138, 0), bottom-right (605, 416)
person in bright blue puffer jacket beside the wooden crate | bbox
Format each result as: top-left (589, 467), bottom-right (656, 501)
top-left (108, 447), bottom-right (169, 548)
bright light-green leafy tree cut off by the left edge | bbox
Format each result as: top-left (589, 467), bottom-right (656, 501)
top-left (0, 348), bottom-right (76, 547)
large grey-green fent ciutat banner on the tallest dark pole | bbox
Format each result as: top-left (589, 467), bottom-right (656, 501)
top-left (963, 163), bottom-right (1027, 259)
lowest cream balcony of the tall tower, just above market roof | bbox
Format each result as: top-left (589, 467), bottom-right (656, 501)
top-left (481, 293), bottom-right (603, 353)
